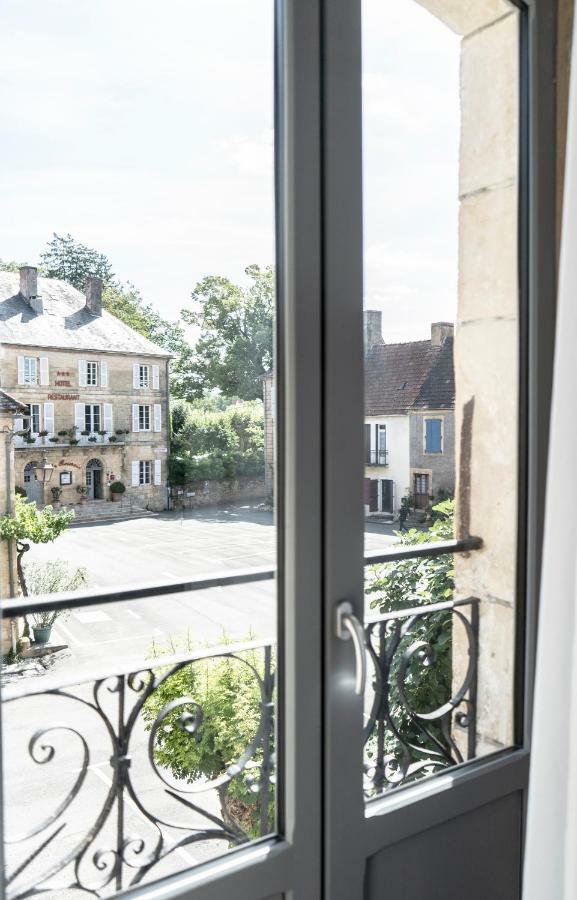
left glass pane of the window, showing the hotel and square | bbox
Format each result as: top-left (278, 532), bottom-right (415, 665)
top-left (0, 0), bottom-right (277, 900)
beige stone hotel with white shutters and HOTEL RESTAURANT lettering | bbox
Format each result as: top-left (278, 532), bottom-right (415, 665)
top-left (0, 266), bottom-right (170, 510)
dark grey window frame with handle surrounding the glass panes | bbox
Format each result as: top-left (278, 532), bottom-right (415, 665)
top-left (0, 0), bottom-right (556, 900)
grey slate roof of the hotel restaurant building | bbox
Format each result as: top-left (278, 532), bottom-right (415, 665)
top-left (0, 272), bottom-right (171, 357)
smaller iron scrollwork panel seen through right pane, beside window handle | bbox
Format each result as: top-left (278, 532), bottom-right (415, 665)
top-left (364, 598), bottom-right (478, 799)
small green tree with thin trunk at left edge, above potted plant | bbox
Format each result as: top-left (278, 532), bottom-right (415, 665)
top-left (0, 494), bottom-right (74, 597)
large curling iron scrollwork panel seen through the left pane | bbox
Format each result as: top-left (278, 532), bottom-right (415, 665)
top-left (4, 642), bottom-right (275, 900)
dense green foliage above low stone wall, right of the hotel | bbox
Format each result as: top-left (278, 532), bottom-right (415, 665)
top-left (169, 400), bottom-right (264, 484)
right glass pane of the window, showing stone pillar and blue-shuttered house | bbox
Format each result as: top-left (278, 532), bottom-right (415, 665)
top-left (363, 0), bottom-right (520, 799)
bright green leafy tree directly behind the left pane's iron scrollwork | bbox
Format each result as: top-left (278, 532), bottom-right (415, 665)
top-left (142, 636), bottom-right (274, 843)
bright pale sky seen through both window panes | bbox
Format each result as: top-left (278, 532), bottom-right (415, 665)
top-left (0, 0), bottom-right (459, 340)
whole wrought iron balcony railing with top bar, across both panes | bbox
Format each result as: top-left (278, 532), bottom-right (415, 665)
top-left (1, 538), bottom-right (481, 900)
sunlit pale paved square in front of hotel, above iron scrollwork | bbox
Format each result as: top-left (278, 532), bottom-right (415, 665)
top-left (29, 506), bottom-right (395, 672)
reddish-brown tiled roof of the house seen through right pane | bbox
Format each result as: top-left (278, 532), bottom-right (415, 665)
top-left (365, 337), bottom-right (455, 416)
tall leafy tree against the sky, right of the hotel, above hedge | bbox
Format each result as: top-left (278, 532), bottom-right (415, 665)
top-left (181, 265), bottom-right (275, 400)
